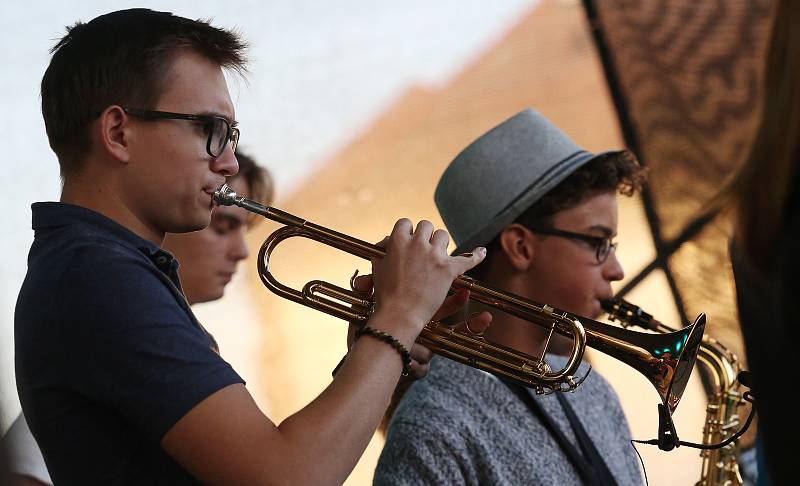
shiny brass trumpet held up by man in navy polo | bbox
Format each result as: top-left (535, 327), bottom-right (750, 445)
top-left (214, 185), bottom-right (705, 412)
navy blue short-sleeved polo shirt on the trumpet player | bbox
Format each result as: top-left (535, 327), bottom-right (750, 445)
top-left (14, 203), bottom-right (243, 484)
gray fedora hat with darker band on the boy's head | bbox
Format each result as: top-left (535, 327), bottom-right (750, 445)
top-left (433, 108), bottom-right (613, 254)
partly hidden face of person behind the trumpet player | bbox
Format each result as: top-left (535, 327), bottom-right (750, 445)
top-left (163, 177), bottom-right (250, 304)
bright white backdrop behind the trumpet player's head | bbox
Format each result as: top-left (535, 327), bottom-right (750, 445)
top-left (0, 0), bottom-right (538, 430)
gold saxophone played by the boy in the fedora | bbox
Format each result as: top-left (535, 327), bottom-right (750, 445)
top-left (603, 299), bottom-right (745, 486)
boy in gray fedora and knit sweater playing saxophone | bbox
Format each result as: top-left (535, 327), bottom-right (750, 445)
top-left (375, 109), bottom-right (644, 485)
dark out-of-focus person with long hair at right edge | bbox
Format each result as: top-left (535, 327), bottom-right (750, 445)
top-left (720, 0), bottom-right (800, 485)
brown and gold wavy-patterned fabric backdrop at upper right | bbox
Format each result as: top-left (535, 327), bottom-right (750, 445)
top-left (584, 0), bottom-right (773, 372)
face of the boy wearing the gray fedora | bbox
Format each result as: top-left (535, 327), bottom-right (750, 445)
top-left (525, 192), bottom-right (624, 318)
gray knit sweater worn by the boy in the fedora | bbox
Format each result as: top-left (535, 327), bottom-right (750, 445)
top-left (374, 358), bottom-right (643, 486)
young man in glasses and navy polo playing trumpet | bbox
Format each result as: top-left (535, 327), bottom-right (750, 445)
top-left (15, 9), bottom-right (485, 485)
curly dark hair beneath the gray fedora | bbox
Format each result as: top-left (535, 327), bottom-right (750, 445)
top-left (467, 150), bottom-right (647, 280)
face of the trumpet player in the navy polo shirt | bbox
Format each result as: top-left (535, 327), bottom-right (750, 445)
top-left (124, 51), bottom-right (238, 234)
